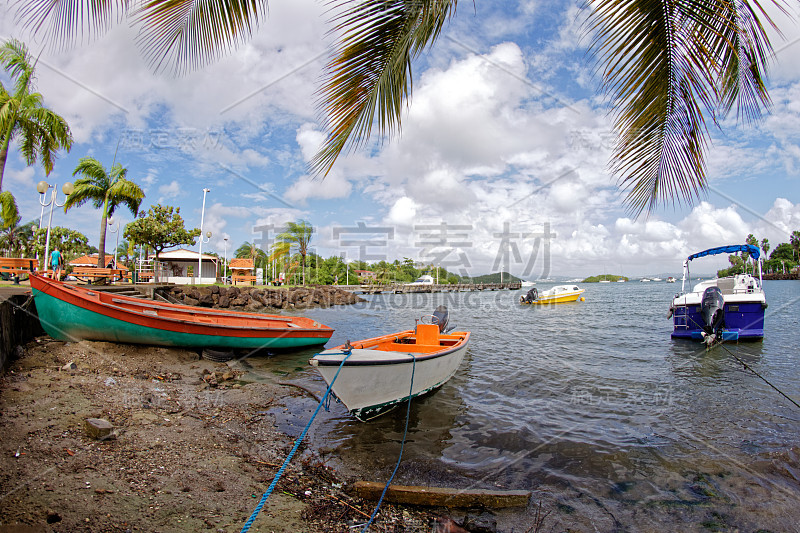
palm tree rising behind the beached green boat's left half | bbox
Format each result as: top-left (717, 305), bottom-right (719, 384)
top-left (64, 157), bottom-right (144, 268)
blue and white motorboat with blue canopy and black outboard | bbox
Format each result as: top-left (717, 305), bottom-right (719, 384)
top-left (669, 244), bottom-right (767, 345)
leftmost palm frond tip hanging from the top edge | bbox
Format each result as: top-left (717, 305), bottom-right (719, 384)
top-left (13, 0), bottom-right (128, 48)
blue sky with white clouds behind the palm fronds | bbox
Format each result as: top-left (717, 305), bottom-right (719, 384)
top-left (0, 0), bottom-right (800, 280)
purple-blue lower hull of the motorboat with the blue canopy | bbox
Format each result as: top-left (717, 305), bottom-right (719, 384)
top-left (672, 302), bottom-right (764, 340)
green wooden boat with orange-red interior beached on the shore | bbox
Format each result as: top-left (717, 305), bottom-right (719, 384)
top-left (30, 274), bottom-right (333, 350)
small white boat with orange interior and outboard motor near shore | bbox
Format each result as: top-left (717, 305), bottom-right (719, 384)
top-left (309, 306), bottom-right (469, 422)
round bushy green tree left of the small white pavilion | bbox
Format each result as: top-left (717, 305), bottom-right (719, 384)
top-left (123, 204), bottom-right (200, 259)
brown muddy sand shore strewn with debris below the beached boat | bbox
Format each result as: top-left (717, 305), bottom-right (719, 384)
top-left (0, 336), bottom-right (442, 532)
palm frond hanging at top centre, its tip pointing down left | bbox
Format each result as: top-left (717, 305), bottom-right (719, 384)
top-left (310, 0), bottom-right (457, 175)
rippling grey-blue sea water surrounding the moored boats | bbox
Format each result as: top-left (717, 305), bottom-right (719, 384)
top-left (244, 281), bottom-right (800, 531)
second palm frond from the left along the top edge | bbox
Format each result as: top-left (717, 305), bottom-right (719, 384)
top-left (135, 0), bottom-right (267, 74)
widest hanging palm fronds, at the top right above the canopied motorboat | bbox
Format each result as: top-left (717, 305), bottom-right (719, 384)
top-left (591, 0), bottom-right (780, 215)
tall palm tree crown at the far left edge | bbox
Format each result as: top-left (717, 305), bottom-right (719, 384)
top-left (0, 39), bottom-right (72, 191)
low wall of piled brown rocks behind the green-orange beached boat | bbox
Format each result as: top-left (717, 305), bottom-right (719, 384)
top-left (169, 285), bottom-right (365, 312)
